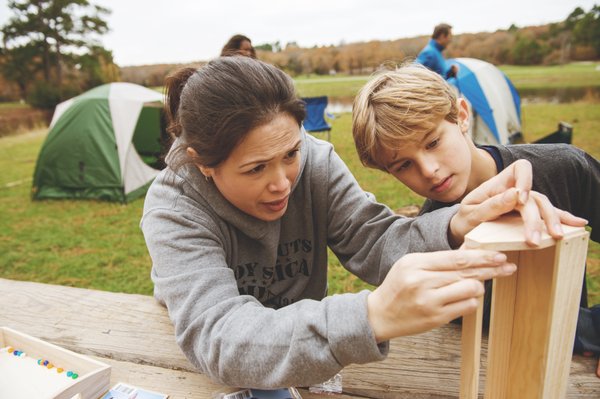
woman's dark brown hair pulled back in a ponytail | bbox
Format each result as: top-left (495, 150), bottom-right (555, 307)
top-left (165, 57), bottom-right (305, 168)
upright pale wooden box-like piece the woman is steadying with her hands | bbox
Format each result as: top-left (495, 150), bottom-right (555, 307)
top-left (461, 216), bottom-right (589, 399)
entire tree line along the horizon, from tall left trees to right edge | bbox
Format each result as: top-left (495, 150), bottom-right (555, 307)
top-left (0, 0), bottom-right (600, 108)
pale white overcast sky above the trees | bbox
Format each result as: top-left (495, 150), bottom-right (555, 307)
top-left (0, 0), bottom-right (600, 66)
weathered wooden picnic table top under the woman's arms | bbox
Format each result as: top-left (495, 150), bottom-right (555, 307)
top-left (0, 279), bottom-right (600, 399)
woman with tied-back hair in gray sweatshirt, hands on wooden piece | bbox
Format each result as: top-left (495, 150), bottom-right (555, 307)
top-left (141, 57), bottom-right (580, 388)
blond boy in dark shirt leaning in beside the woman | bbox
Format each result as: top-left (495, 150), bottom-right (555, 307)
top-left (352, 64), bottom-right (600, 377)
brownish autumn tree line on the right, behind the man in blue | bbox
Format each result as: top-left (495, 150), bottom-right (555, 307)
top-left (257, 5), bottom-right (600, 75)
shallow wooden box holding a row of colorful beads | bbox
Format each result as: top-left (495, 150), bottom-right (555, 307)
top-left (0, 327), bottom-right (110, 399)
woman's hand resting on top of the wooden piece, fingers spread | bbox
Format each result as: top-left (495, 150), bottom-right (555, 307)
top-left (448, 159), bottom-right (587, 246)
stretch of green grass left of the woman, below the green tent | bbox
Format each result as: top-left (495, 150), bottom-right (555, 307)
top-left (0, 130), bottom-right (152, 294)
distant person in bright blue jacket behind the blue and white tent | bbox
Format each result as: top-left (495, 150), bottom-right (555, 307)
top-left (416, 23), bottom-right (458, 79)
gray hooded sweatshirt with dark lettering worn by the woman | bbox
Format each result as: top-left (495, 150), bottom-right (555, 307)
top-left (141, 132), bottom-right (456, 388)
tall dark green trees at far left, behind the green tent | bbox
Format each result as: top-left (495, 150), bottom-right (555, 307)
top-left (0, 0), bottom-right (120, 108)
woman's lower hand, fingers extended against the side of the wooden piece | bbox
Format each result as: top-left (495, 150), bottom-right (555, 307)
top-left (367, 249), bottom-right (516, 342)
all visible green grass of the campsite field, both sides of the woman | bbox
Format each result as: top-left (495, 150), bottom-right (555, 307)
top-left (0, 63), bottom-right (600, 303)
